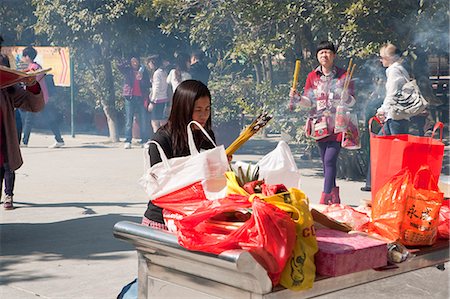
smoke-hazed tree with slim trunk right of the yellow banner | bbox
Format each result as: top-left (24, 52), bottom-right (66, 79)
top-left (33, 0), bottom-right (176, 142)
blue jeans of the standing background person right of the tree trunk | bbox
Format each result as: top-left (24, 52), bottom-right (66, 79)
top-left (125, 96), bottom-right (150, 143)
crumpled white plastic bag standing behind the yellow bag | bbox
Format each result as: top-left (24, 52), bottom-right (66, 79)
top-left (256, 141), bottom-right (300, 189)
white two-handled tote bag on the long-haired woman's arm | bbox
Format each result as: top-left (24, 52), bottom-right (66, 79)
top-left (139, 121), bottom-right (229, 200)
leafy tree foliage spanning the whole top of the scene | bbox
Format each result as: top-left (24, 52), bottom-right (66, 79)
top-left (0, 0), bottom-right (449, 141)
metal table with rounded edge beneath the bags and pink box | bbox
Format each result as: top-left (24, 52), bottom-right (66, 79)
top-left (113, 221), bottom-right (449, 299)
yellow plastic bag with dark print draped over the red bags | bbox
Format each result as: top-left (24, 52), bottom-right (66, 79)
top-left (225, 172), bottom-right (319, 291)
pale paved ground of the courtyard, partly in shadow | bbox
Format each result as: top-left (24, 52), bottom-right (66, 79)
top-left (0, 133), bottom-right (449, 299)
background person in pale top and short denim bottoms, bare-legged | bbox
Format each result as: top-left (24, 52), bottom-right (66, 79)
top-left (147, 55), bottom-right (171, 133)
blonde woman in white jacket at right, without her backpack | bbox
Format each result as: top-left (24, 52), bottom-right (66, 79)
top-left (377, 43), bottom-right (409, 135)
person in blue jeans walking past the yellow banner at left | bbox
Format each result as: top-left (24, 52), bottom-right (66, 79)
top-left (21, 46), bottom-right (64, 148)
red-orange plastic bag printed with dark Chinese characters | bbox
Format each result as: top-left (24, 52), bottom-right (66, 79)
top-left (400, 166), bottom-right (444, 246)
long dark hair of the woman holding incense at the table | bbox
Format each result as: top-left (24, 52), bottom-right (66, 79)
top-left (163, 80), bottom-right (212, 156)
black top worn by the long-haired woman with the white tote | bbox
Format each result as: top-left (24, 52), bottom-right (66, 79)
top-left (144, 128), bottom-right (216, 223)
